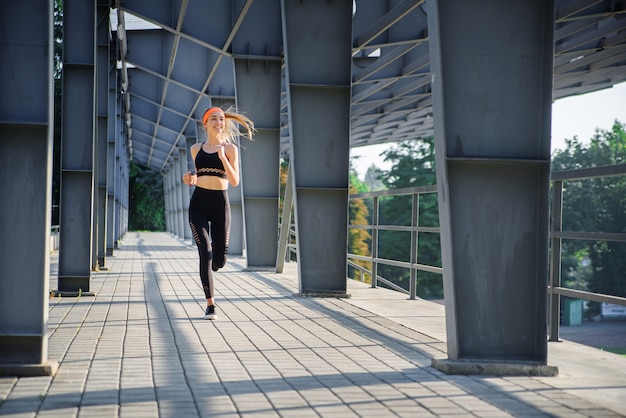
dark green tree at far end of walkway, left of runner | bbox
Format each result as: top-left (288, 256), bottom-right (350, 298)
top-left (128, 161), bottom-right (165, 231)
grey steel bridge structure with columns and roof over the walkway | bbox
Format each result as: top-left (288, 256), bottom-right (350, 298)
top-left (0, 0), bottom-right (626, 374)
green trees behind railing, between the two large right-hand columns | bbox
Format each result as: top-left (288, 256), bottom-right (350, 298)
top-left (378, 137), bottom-right (443, 298)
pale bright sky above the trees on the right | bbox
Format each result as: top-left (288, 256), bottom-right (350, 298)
top-left (350, 83), bottom-right (626, 178)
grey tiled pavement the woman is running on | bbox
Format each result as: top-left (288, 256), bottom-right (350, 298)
top-left (0, 233), bottom-right (626, 417)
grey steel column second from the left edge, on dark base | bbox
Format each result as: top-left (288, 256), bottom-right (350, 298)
top-left (58, 0), bottom-right (96, 292)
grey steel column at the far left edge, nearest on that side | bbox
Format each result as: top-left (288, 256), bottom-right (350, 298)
top-left (0, 0), bottom-right (57, 376)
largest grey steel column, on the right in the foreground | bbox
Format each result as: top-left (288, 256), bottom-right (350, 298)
top-left (428, 0), bottom-right (555, 375)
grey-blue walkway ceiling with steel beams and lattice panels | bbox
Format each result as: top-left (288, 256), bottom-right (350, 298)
top-left (111, 0), bottom-right (626, 171)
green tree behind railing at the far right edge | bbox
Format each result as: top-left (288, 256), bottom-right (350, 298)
top-left (552, 121), bottom-right (626, 313)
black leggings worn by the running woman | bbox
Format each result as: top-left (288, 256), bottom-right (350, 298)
top-left (189, 187), bottom-right (230, 299)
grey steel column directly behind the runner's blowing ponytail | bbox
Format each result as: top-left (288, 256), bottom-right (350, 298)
top-left (232, 0), bottom-right (282, 270)
